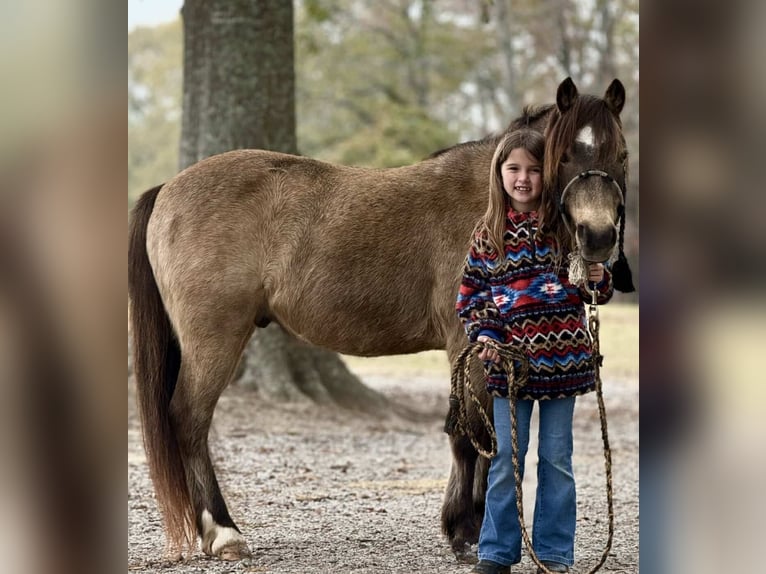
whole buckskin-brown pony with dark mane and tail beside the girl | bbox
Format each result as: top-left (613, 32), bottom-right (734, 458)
top-left (128, 78), bottom-right (627, 560)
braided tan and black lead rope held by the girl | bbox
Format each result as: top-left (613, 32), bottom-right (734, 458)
top-left (444, 289), bottom-right (614, 574)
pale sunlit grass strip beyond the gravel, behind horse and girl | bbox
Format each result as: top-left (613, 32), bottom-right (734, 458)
top-left (343, 303), bottom-right (638, 380)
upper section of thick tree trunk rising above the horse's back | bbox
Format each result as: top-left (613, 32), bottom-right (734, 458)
top-left (181, 0), bottom-right (297, 162)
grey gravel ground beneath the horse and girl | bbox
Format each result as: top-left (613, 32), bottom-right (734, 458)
top-left (128, 369), bottom-right (639, 574)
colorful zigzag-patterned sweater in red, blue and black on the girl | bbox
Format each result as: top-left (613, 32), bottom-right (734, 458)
top-left (456, 209), bottom-right (613, 399)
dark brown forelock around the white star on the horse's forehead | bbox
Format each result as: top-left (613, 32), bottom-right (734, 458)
top-left (543, 94), bottom-right (626, 189)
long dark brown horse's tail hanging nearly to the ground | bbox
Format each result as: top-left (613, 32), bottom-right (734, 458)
top-left (128, 185), bottom-right (196, 551)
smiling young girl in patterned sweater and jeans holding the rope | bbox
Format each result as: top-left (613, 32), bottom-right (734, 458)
top-left (456, 129), bottom-right (612, 574)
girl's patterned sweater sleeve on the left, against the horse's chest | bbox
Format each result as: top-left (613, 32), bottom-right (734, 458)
top-left (455, 236), bottom-right (503, 343)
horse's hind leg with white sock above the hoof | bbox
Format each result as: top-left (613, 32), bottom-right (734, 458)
top-left (170, 324), bottom-right (254, 560)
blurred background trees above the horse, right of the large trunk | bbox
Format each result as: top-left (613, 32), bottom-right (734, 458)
top-left (296, 0), bottom-right (639, 300)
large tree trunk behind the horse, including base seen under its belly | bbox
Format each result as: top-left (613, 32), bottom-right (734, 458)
top-left (180, 0), bottom-right (385, 411)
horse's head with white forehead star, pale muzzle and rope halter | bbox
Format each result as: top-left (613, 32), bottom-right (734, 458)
top-left (544, 78), bottom-right (628, 262)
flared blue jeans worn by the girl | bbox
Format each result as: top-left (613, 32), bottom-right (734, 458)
top-left (479, 397), bottom-right (577, 566)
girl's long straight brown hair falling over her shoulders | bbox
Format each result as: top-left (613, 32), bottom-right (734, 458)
top-left (479, 128), bottom-right (571, 262)
